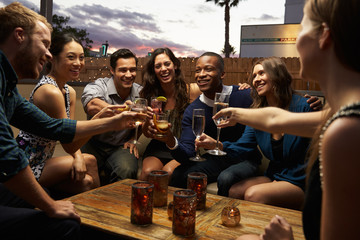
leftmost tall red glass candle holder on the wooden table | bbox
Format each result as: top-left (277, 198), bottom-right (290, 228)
top-left (131, 182), bottom-right (154, 225)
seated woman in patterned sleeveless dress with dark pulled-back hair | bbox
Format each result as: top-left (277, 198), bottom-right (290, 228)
top-left (16, 33), bottom-right (100, 194)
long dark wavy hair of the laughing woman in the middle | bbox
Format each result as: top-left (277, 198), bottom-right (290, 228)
top-left (140, 48), bottom-right (189, 114)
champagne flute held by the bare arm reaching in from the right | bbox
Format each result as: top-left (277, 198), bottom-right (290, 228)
top-left (207, 93), bottom-right (230, 156)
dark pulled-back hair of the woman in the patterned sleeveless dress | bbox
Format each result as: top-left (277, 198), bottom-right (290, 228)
top-left (46, 33), bottom-right (82, 71)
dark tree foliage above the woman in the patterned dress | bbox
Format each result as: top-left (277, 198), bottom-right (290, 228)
top-left (52, 14), bottom-right (93, 57)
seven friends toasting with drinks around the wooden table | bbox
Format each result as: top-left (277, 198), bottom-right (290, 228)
top-left (0, 0), bottom-right (360, 239)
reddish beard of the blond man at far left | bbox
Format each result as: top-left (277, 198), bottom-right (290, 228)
top-left (13, 38), bottom-right (39, 80)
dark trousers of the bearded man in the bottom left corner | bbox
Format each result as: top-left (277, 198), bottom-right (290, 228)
top-left (0, 184), bottom-right (81, 240)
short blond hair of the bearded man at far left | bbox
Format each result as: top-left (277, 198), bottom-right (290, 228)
top-left (0, 2), bottom-right (52, 44)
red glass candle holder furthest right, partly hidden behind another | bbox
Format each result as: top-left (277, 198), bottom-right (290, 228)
top-left (187, 172), bottom-right (207, 210)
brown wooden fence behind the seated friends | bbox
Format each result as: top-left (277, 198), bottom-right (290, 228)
top-left (74, 57), bottom-right (320, 91)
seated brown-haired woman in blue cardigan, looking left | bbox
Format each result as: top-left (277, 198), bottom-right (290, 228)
top-left (199, 57), bottom-right (311, 209)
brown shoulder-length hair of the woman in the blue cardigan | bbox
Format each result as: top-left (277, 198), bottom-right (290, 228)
top-left (248, 57), bottom-right (294, 109)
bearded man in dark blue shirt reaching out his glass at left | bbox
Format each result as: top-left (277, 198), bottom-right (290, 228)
top-left (0, 2), bottom-right (146, 239)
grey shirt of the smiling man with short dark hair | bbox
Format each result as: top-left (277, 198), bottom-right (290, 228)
top-left (81, 77), bottom-right (142, 146)
